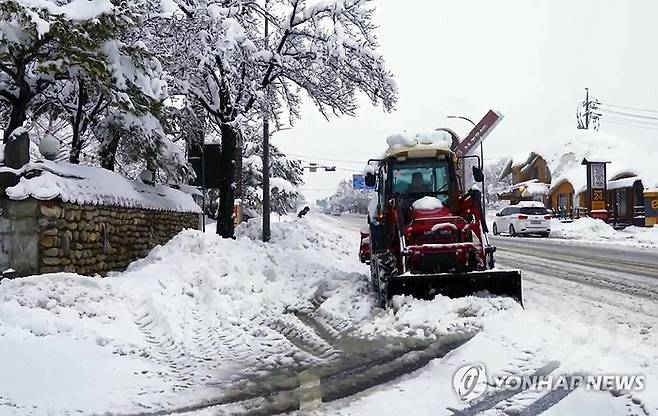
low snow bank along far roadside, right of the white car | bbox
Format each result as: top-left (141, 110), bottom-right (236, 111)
top-left (551, 217), bottom-right (658, 247)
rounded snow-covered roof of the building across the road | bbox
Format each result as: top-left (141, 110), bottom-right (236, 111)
top-left (504, 130), bottom-right (658, 193)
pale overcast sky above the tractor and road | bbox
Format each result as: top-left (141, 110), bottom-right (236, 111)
top-left (272, 0), bottom-right (658, 201)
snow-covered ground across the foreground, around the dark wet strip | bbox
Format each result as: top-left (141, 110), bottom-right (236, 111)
top-left (0, 214), bottom-right (658, 415)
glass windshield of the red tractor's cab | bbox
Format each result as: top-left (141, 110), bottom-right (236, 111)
top-left (393, 160), bottom-right (449, 202)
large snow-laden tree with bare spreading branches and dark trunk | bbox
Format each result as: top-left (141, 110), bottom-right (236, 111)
top-left (153, 0), bottom-right (396, 237)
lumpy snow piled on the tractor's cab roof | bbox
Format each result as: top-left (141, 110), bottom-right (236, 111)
top-left (385, 130), bottom-right (454, 158)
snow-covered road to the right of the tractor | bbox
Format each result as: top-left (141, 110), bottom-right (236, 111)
top-left (310, 217), bottom-right (658, 415)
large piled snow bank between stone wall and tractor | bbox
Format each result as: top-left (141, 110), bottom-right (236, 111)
top-left (0, 215), bottom-right (368, 415)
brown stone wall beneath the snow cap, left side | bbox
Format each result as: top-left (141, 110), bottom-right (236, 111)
top-left (0, 199), bottom-right (199, 276)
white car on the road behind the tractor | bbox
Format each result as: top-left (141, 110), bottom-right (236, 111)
top-left (492, 202), bottom-right (551, 237)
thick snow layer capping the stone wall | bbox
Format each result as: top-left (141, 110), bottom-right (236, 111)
top-left (0, 161), bottom-right (201, 213)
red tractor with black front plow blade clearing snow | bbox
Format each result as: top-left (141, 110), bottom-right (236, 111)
top-left (359, 130), bottom-right (522, 307)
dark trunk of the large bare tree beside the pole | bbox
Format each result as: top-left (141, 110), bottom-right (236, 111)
top-left (217, 124), bottom-right (239, 238)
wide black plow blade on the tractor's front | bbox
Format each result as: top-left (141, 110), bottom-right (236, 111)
top-left (388, 270), bottom-right (523, 306)
